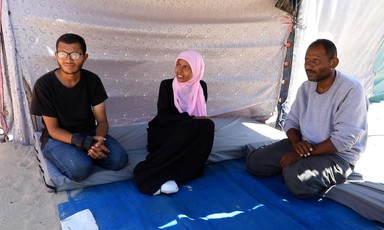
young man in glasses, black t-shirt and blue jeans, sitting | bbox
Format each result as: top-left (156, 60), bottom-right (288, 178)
top-left (31, 34), bottom-right (128, 181)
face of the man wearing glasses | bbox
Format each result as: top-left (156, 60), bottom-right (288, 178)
top-left (55, 42), bottom-right (88, 74)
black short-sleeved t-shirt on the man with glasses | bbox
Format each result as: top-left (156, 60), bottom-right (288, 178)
top-left (31, 69), bottom-right (108, 146)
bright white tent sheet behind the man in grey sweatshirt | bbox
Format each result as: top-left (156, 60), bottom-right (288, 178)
top-left (285, 0), bottom-right (384, 114)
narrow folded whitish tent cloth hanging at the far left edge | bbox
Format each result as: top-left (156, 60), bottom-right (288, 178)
top-left (1, 0), bottom-right (33, 144)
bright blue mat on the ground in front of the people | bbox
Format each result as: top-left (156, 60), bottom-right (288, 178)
top-left (58, 159), bottom-right (379, 230)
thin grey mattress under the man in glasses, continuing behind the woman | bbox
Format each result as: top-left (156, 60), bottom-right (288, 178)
top-left (35, 118), bottom-right (285, 192)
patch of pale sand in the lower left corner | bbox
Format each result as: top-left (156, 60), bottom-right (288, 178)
top-left (0, 142), bottom-right (67, 230)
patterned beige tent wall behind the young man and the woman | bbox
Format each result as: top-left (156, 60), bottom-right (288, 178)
top-left (2, 0), bottom-right (290, 143)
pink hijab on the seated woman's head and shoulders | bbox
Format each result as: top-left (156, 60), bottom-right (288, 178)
top-left (172, 50), bottom-right (207, 116)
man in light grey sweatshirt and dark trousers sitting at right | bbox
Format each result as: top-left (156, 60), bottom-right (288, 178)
top-left (247, 39), bottom-right (368, 198)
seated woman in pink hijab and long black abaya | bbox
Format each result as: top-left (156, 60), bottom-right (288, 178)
top-left (134, 50), bottom-right (214, 195)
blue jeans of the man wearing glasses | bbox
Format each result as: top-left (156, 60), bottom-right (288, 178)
top-left (42, 135), bottom-right (128, 181)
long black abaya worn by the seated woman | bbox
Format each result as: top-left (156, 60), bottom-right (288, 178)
top-left (134, 79), bottom-right (214, 195)
